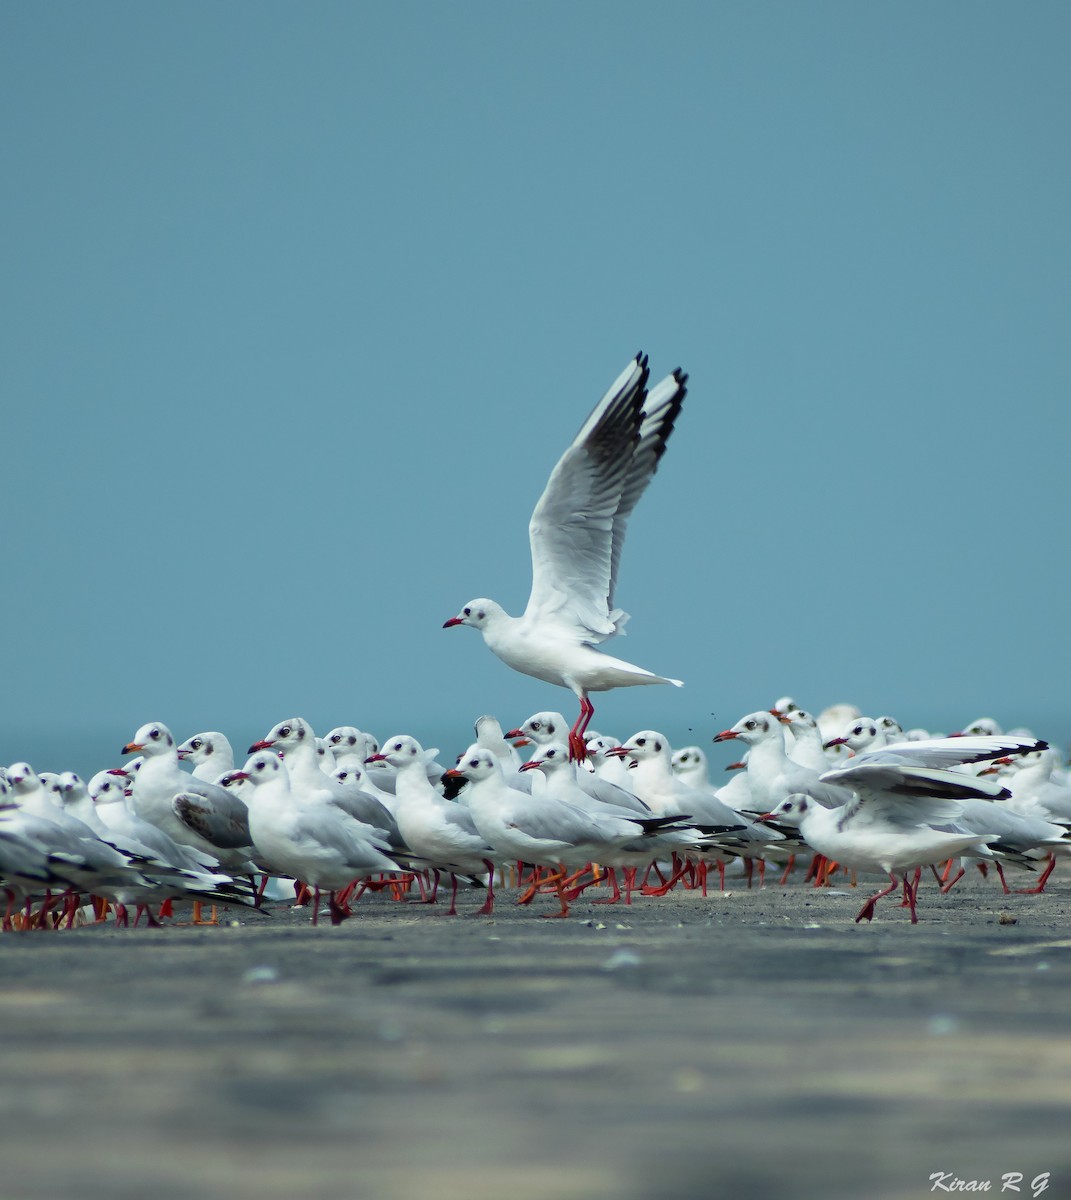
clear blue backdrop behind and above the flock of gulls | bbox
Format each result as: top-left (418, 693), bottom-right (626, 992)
top-left (0, 2), bottom-right (1071, 772)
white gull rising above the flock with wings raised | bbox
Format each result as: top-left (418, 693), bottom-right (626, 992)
top-left (443, 354), bottom-right (687, 760)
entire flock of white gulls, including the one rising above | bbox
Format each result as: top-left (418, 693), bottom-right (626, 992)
top-left (0, 355), bottom-right (1071, 930)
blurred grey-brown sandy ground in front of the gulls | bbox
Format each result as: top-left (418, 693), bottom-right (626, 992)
top-left (0, 870), bottom-right (1071, 1200)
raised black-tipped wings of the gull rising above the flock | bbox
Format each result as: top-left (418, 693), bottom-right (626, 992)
top-left (526, 354), bottom-right (686, 642)
